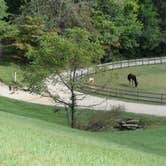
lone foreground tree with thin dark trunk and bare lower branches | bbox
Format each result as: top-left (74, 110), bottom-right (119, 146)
top-left (25, 28), bottom-right (103, 128)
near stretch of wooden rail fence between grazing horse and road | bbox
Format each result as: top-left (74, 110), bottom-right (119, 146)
top-left (80, 85), bottom-right (166, 104)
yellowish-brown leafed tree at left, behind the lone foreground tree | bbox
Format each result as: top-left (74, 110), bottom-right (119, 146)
top-left (13, 16), bottom-right (44, 62)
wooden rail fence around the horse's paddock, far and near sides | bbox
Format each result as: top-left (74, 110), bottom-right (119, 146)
top-left (77, 57), bottom-right (166, 104)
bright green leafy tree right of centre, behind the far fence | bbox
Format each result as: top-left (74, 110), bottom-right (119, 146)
top-left (93, 0), bottom-right (142, 61)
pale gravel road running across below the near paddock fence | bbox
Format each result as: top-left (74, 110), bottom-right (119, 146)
top-left (0, 80), bottom-right (166, 116)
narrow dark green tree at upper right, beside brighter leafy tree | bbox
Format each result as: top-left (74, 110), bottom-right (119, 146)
top-left (139, 0), bottom-right (161, 50)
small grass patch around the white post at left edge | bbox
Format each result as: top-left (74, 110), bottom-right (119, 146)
top-left (0, 63), bottom-right (23, 85)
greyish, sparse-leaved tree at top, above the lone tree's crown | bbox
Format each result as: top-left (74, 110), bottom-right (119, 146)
top-left (23, 0), bottom-right (92, 31)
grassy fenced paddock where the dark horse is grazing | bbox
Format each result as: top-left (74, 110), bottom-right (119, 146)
top-left (94, 64), bottom-right (166, 93)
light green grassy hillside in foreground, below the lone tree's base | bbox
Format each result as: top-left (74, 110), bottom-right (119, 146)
top-left (0, 112), bottom-right (166, 166)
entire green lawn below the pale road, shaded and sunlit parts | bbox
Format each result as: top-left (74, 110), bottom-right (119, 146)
top-left (0, 98), bottom-right (166, 166)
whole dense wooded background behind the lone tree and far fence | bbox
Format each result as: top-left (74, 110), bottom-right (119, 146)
top-left (0, 0), bottom-right (166, 62)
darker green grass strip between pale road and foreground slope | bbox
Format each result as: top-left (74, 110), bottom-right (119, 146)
top-left (0, 97), bottom-right (166, 129)
